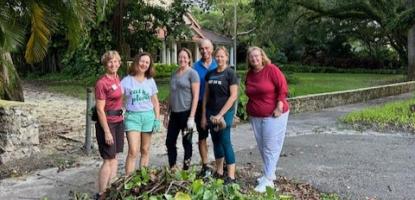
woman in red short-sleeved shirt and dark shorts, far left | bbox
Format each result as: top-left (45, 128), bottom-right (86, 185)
top-left (95, 51), bottom-right (124, 199)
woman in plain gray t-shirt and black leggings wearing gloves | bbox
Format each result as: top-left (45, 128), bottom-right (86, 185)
top-left (163, 48), bottom-right (199, 170)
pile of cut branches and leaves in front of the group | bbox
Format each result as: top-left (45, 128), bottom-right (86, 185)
top-left (90, 164), bottom-right (339, 200)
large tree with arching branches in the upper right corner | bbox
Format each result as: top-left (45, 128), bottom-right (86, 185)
top-left (292, 0), bottom-right (415, 80)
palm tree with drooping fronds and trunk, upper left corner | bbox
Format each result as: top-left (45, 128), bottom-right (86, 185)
top-left (0, 0), bottom-right (103, 101)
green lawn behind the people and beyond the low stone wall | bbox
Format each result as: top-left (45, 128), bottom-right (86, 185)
top-left (32, 73), bottom-right (404, 100)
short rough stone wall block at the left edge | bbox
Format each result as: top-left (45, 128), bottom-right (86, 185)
top-left (0, 100), bottom-right (39, 165)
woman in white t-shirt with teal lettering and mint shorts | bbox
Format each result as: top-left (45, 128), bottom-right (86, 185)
top-left (121, 52), bottom-right (160, 175)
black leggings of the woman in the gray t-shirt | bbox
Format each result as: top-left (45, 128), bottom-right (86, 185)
top-left (166, 110), bottom-right (192, 170)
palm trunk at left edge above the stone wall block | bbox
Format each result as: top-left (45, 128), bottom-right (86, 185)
top-left (0, 52), bottom-right (24, 101)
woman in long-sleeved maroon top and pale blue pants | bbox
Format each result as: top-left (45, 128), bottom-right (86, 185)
top-left (245, 47), bottom-right (289, 192)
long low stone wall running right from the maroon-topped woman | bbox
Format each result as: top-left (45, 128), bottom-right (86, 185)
top-left (288, 81), bottom-right (415, 113)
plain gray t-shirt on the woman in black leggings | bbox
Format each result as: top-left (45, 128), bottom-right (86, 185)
top-left (170, 68), bottom-right (199, 112)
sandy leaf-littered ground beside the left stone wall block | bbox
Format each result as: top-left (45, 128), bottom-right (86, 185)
top-left (0, 82), bottom-right (98, 179)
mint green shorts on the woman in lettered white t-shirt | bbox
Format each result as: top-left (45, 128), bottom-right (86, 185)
top-left (124, 110), bottom-right (156, 133)
